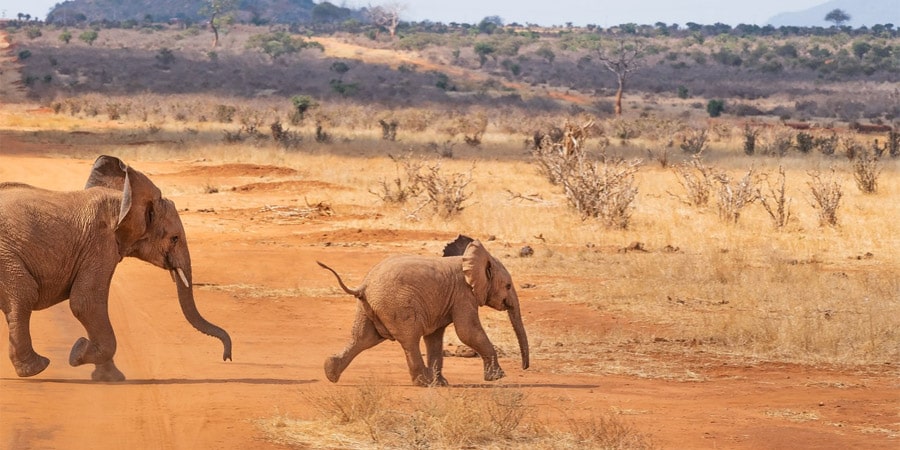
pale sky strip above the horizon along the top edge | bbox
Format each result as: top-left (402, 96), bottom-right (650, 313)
top-left (0, 0), bottom-right (827, 27)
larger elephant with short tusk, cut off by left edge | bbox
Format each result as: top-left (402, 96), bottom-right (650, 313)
top-left (0, 156), bottom-right (231, 381)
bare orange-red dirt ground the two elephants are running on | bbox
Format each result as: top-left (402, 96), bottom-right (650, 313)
top-left (0, 145), bottom-right (900, 449)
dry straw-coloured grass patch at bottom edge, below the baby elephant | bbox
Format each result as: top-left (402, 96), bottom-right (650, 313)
top-left (259, 382), bottom-right (652, 449)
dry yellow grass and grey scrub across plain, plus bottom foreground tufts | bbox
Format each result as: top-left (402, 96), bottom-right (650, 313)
top-left (3, 14), bottom-right (900, 448)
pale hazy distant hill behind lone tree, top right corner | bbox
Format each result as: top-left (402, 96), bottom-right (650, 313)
top-left (769, 0), bottom-right (900, 27)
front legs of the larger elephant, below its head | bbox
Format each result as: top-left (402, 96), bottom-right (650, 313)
top-left (69, 292), bottom-right (125, 381)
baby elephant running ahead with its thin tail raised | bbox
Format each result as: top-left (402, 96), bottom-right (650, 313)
top-left (319, 236), bottom-right (528, 386)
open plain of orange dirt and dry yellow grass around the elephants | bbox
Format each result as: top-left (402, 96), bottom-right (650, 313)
top-left (0, 22), bottom-right (900, 449)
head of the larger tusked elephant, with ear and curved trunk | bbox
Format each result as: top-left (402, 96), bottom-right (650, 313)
top-left (85, 156), bottom-right (231, 360)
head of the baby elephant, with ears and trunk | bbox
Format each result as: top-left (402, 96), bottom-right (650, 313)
top-left (444, 235), bottom-right (529, 369)
